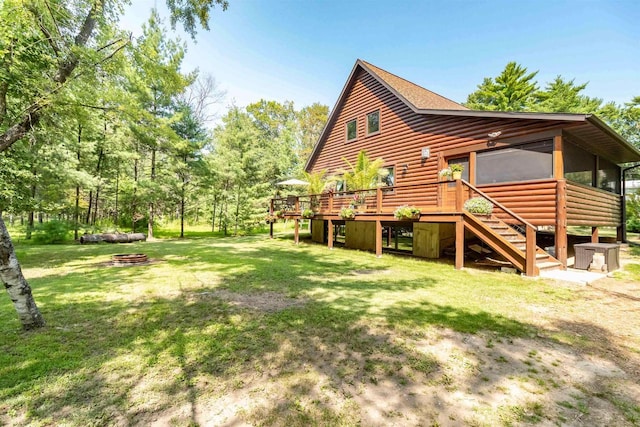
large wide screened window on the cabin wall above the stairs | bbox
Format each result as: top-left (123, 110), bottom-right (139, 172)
top-left (476, 140), bottom-right (553, 185)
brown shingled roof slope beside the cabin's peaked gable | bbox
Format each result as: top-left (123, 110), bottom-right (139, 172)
top-left (360, 60), bottom-right (468, 110)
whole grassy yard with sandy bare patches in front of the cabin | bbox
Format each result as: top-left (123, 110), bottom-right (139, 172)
top-left (0, 233), bottom-right (640, 426)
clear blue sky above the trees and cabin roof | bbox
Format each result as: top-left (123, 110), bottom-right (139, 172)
top-left (122, 0), bottom-right (640, 118)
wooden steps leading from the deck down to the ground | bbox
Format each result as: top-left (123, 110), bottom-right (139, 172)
top-left (465, 216), bottom-right (563, 276)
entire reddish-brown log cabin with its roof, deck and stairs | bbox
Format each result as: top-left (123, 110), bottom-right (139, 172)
top-left (271, 60), bottom-right (640, 276)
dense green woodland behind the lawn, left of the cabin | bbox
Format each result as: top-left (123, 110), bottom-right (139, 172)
top-left (0, 2), bottom-right (328, 244)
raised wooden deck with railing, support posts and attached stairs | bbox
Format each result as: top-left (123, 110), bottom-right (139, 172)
top-left (271, 180), bottom-right (562, 276)
